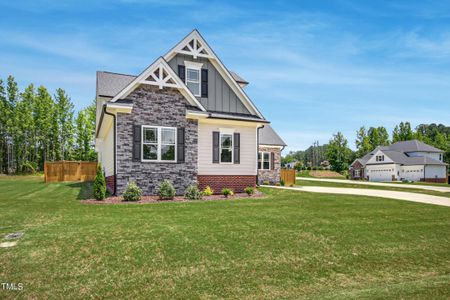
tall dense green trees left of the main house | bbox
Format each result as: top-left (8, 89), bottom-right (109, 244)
top-left (0, 76), bottom-right (97, 174)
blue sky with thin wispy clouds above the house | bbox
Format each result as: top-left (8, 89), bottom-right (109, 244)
top-left (0, 0), bottom-right (450, 150)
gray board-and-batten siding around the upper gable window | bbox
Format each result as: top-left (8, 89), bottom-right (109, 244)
top-left (169, 54), bottom-right (250, 114)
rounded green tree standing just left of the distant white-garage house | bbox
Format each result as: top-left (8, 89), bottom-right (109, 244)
top-left (326, 132), bottom-right (352, 173)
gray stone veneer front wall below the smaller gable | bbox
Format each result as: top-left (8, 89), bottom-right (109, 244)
top-left (117, 86), bottom-right (198, 195)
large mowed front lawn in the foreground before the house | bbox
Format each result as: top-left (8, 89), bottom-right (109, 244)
top-left (0, 177), bottom-right (450, 299)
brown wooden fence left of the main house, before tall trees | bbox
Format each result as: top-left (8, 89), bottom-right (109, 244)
top-left (44, 161), bottom-right (97, 182)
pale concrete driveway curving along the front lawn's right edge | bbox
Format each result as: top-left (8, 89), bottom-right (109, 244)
top-left (264, 185), bottom-right (450, 206)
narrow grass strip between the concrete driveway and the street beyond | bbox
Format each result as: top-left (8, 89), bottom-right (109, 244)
top-left (295, 179), bottom-right (450, 197)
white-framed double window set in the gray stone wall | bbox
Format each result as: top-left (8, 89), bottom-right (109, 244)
top-left (142, 126), bottom-right (177, 162)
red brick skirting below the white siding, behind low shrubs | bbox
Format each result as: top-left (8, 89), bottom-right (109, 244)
top-left (197, 175), bottom-right (256, 194)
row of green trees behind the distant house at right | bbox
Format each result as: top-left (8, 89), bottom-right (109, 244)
top-left (282, 122), bottom-right (450, 173)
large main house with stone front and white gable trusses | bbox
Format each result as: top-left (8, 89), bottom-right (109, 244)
top-left (96, 30), bottom-right (284, 194)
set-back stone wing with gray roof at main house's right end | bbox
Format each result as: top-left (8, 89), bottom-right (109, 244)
top-left (258, 125), bottom-right (286, 184)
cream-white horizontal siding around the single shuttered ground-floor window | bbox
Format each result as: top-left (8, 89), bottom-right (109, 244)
top-left (198, 121), bottom-right (257, 175)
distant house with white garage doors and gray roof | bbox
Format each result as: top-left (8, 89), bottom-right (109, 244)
top-left (350, 140), bottom-right (447, 182)
